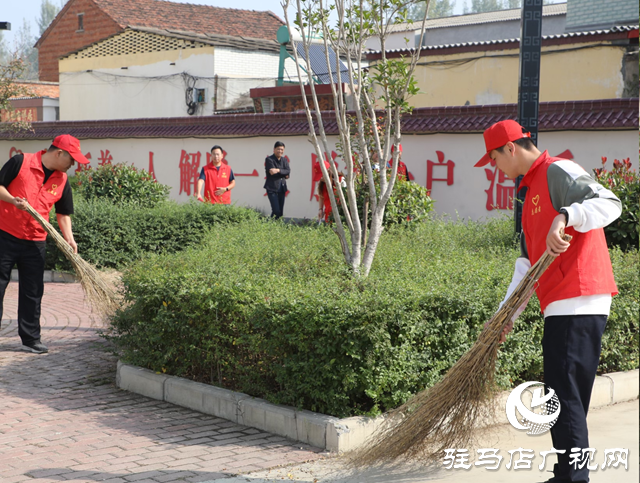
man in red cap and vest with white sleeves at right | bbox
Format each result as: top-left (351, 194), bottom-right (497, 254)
top-left (475, 120), bottom-right (622, 483)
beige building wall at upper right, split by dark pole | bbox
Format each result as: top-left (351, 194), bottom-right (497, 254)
top-left (409, 44), bottom-right (625, 107)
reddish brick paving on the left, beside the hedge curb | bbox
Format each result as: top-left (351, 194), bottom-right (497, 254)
top-left (0, 283), bottom-right (321, 483)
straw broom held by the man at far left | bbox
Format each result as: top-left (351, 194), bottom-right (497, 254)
top-left (26, 203), bottom-right (120, 316)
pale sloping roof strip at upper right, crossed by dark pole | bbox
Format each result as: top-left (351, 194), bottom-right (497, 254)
top-left (380, 3), bottom-right (567, 32)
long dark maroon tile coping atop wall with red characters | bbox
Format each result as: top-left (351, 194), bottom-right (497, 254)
top-left (0, 98), bottom-right (638, 139)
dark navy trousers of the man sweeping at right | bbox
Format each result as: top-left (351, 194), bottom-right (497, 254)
top-left (542, 315), bottom-right (607, 482)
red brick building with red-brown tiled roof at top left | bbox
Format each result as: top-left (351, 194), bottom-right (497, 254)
top-left (36, 0), bottom-right (283, 82)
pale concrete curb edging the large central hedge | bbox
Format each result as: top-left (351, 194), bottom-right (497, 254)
top-left (116, 361), bottom-right (640, 452)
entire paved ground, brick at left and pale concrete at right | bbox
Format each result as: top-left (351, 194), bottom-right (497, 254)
top-left (0, 283), bottom-right (639, 483)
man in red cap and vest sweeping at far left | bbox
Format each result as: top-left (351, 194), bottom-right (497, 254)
top-left (0, 134), bottom-right (89, 354)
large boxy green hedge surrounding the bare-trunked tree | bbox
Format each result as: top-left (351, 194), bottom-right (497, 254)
top-left (108, 220), bottom-right (640, 417)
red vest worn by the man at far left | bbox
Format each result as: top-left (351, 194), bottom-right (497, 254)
top-left (0, 151), bottom-right (67, 241)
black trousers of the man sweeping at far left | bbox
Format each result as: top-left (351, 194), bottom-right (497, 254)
top-left (0, 236), bottom-right (46, 343)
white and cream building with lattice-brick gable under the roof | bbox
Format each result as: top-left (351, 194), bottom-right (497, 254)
top-left (59, 27), bottom-right (295, 121)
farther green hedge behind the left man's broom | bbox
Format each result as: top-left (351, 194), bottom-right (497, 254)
top-left (46, 197), bottom-right (261, 271)
